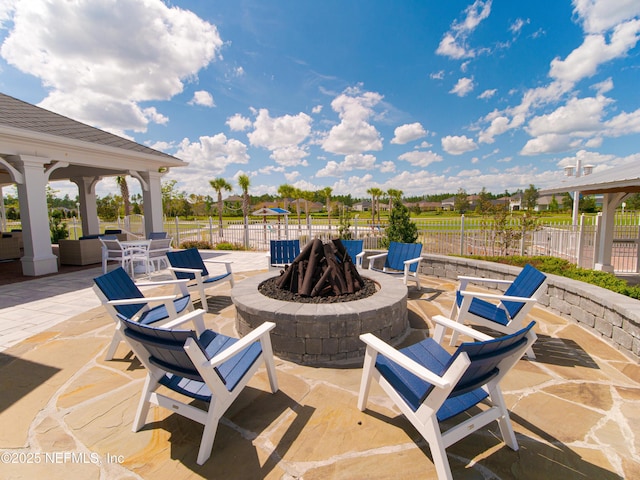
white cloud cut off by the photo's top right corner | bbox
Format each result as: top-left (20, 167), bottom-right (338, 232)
top-left (573, 0), bottom-right (640, 33)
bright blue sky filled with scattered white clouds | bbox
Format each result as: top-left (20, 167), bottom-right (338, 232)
top-left (0, 0), bottom-right (640, 197)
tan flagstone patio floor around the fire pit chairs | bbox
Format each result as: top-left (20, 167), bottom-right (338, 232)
top-left (0, 252), bottom-right (640, 480)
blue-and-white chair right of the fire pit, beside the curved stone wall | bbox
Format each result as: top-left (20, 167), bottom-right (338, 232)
top-left (450, 264), bottom-right (547, 359)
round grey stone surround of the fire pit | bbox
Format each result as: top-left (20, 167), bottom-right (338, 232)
top-left (231, 240), bottom-right (409, 366)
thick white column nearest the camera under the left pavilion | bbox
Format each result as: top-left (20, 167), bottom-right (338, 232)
top-left (11, 155), bottom-right (58, 276)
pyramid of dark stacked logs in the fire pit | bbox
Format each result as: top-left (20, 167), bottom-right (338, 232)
top-left (276, 239), bottom-right (364, 297)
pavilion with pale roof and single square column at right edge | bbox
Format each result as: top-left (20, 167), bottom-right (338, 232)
top-left (540, 163), bottom-right (640, 272)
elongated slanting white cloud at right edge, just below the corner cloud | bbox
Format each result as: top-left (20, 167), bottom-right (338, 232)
top-left (549, 20), bottom-right (640, 83)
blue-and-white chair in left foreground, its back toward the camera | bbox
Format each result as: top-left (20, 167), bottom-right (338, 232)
top-left (121, 310), bottom-right (278, 465)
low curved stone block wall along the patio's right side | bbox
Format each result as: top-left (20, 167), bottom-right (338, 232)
top-left (420, 254), bottom-right (640, 362)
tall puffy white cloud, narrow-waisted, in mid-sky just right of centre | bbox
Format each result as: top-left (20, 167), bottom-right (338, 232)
top-left (321, 88), bottom-right (382, 155)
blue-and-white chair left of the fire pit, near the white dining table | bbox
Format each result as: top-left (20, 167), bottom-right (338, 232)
top-left (166, 248), bottom-right (234, 312)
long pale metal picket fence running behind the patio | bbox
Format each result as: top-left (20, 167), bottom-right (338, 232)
top-left (6, 212), bottom-right (640, 273)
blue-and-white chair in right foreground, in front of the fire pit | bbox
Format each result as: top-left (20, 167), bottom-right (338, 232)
top-left (358, 315), bottom-right (536, 480)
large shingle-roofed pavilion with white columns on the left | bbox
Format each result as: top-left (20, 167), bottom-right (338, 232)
top-left (0, 93), bottom-right (186, 276)
